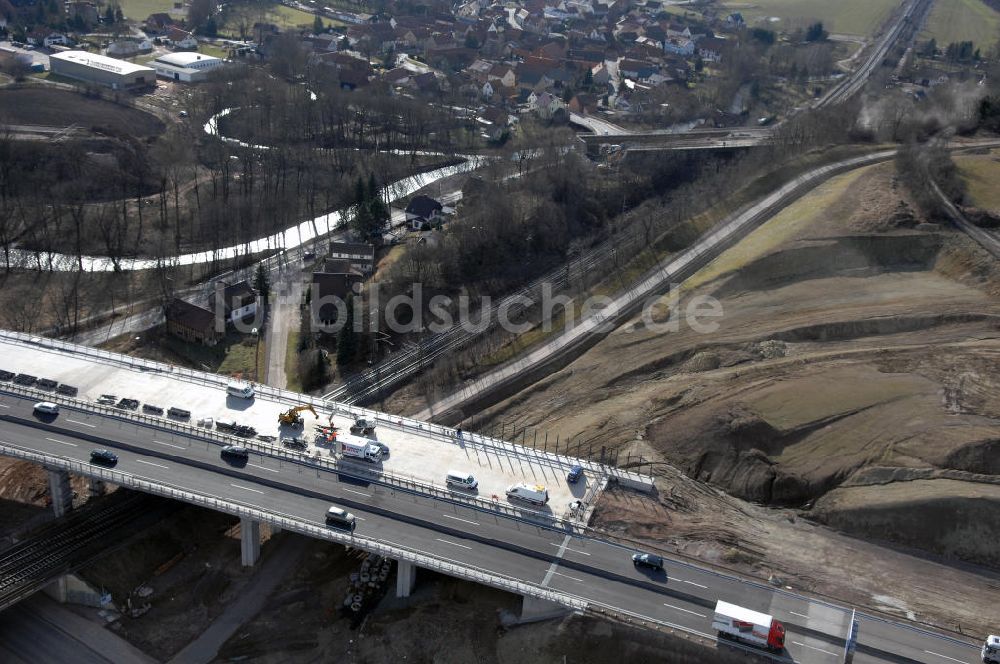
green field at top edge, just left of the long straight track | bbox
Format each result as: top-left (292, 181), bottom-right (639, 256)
top-left (724, 0), bottom-right (900, 36)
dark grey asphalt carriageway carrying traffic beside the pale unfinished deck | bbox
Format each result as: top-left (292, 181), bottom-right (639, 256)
top-left (0, 395), bottom-right (978, 664)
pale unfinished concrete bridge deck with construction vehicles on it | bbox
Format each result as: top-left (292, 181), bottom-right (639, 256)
top-left (0, 337), bottom-right (598, 516)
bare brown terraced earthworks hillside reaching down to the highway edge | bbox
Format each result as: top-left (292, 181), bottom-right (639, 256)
top-left (464, 163), bottom-right (1000, 631)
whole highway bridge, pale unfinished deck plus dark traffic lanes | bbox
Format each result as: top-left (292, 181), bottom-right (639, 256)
top-left (0, 332), bottom-right (977, 664)
